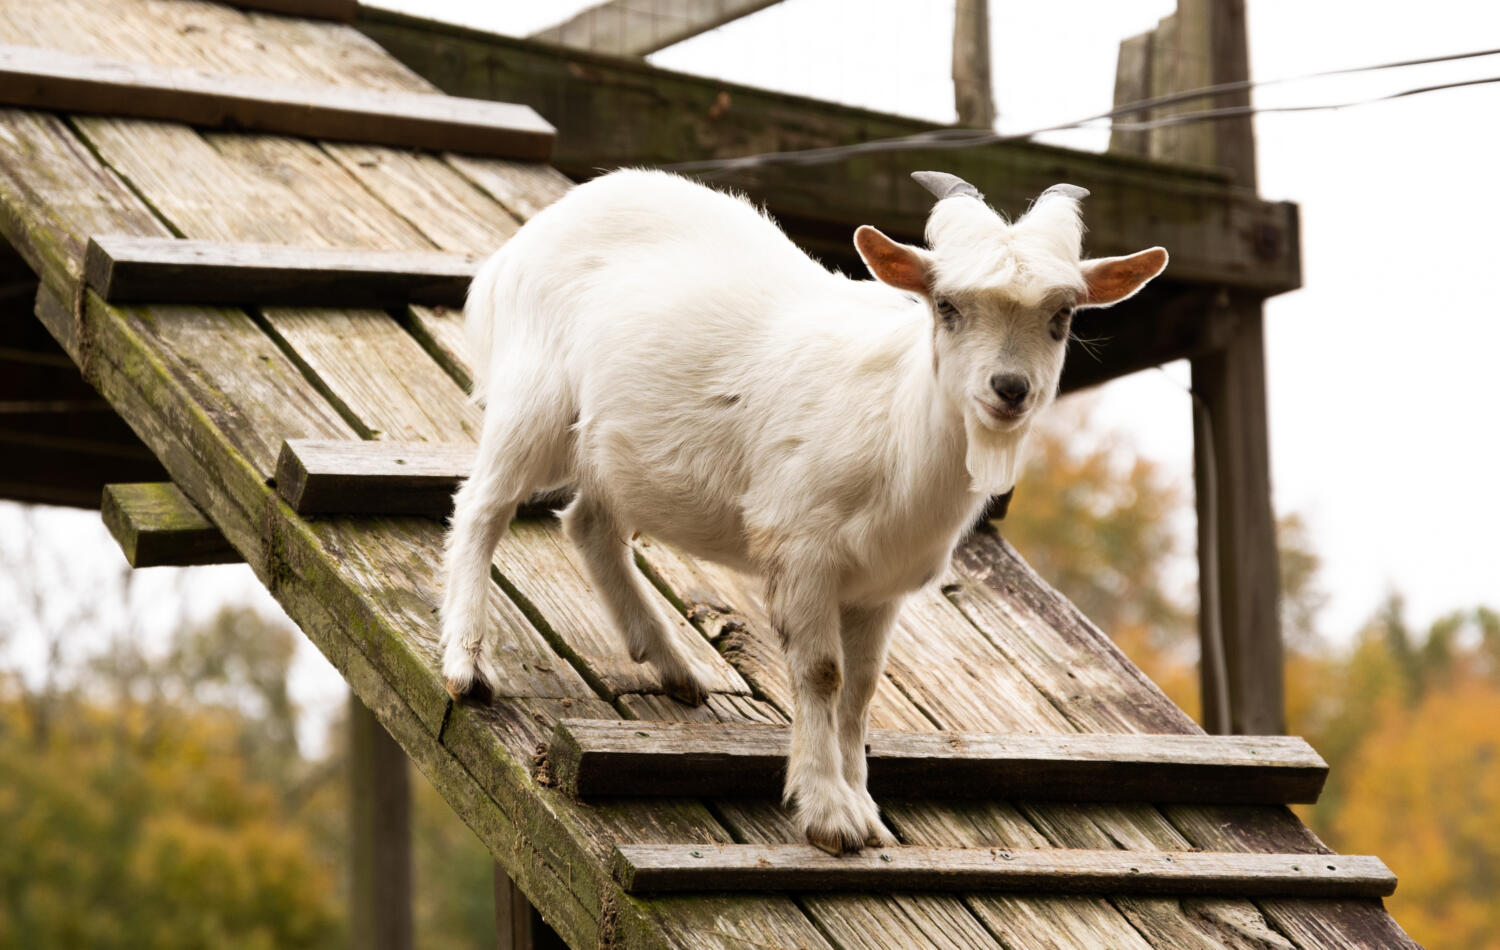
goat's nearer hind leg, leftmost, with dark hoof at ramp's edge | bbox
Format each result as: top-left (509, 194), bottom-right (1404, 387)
top-left (441, 374), bottom-right (570, 699)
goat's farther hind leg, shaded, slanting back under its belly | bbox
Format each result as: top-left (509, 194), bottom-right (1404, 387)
top-left (563, 491), bottom-right (708, 705)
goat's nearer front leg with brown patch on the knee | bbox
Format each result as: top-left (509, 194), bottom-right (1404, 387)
top-left (767, 561), bottom-right (869, 854)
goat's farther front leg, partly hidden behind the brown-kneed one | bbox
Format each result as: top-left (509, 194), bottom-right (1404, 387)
top-left (839, 600), bottom-right (902, 846)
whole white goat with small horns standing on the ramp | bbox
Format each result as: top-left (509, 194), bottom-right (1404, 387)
top-left (443, 171), bottom-right (1167, 852)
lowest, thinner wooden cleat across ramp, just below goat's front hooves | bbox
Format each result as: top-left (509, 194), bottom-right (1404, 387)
top-left (612, 843), bottom-right (1397, 899)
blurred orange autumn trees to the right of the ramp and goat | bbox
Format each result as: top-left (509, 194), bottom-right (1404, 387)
top-left (1001, 413), bottom-right (1500, 950)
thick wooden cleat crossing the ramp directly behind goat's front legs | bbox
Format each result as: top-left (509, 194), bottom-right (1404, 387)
top-left (548, 719), bottom-right (1328, 804)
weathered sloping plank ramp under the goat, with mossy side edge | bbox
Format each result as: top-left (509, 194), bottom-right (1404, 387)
top-left (0, 0), bottom-right (1413, 950)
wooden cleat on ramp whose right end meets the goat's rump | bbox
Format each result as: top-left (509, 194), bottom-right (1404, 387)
top-left (84, 234), bottom-right (479, 308)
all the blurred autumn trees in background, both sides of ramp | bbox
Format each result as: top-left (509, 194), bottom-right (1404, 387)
top-left (0, 413), bottom-right (1500, 950)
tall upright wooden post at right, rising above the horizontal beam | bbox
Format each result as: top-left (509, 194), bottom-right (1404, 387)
top-left (1110, 0), bottom-right (1286, 734)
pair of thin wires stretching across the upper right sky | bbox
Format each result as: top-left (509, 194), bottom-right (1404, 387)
top-left (662, 50), bottom-right (1500, 174)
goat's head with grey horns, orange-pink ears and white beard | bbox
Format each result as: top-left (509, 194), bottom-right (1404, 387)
top-left (855, 171), bottom-right (1167, 492)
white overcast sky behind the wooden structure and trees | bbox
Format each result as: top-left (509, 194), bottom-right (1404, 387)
top-left (0, 0), bottom-right (1500, 747)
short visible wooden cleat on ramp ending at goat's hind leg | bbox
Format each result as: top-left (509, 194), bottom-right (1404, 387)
top-left (276, 440), bottom-right (476, 518)
